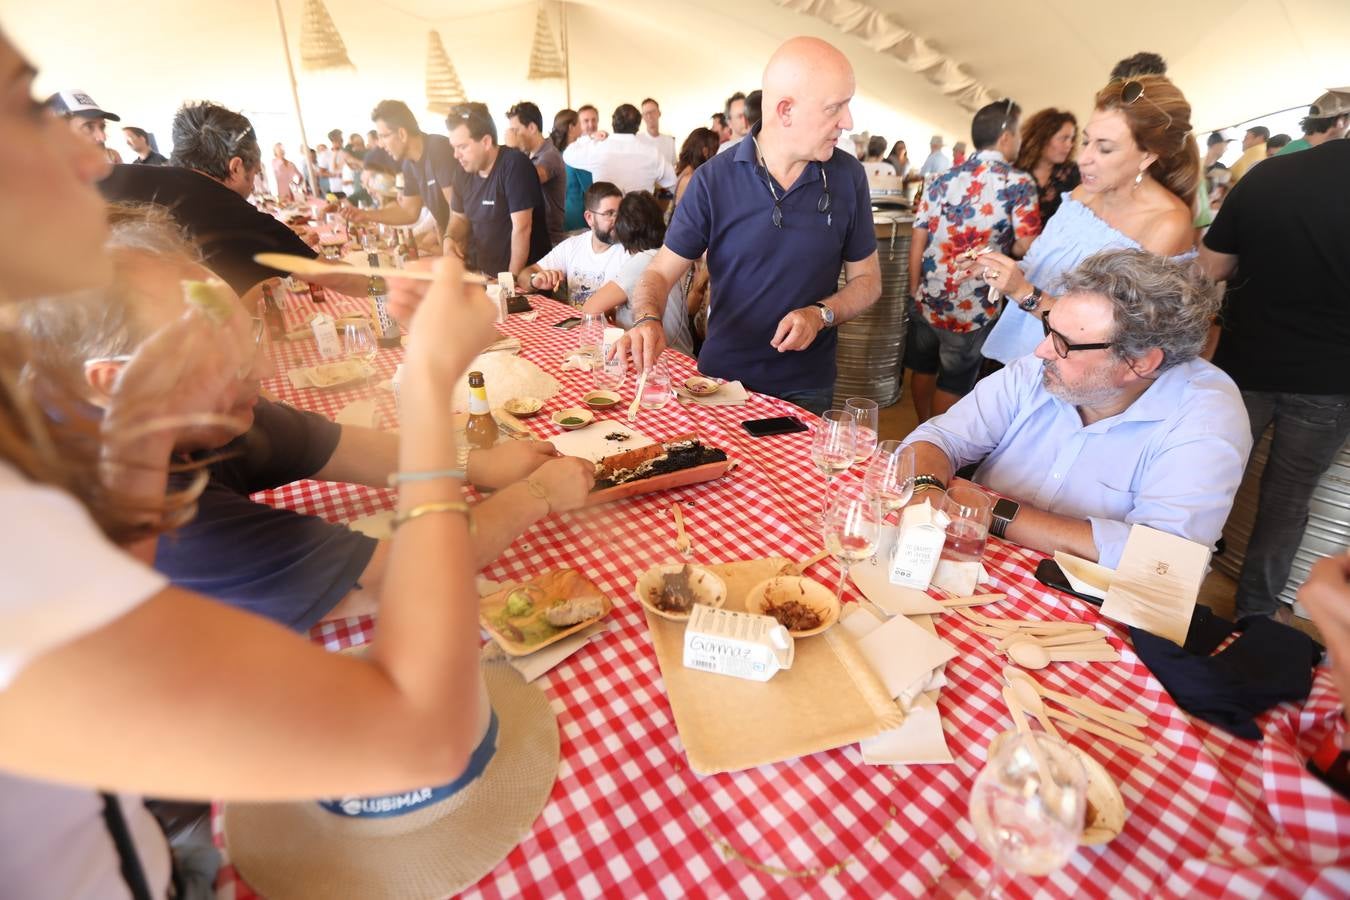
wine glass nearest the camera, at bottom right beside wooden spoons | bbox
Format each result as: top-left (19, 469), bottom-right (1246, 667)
top-left (971, 731), bottom-right (1088, 897)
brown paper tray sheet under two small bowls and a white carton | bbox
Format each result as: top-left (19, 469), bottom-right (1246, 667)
top-left (644, 559), bottom-right (903, 775)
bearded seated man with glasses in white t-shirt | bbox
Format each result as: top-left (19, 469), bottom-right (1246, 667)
top-left (516, 181), bottom-right (628, 306)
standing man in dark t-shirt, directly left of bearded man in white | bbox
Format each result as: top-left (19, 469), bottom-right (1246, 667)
top-left (446, 103), bottom-right (551, 277)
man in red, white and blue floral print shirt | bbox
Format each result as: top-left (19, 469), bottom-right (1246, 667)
top-left (905, 100), bottom-right (1041, 422)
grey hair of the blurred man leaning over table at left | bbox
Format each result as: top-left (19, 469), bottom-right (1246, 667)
top-left (22, 204), bottom-right (201, 376)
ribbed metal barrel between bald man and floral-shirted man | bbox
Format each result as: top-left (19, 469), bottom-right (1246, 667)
top-left (834, 210), bottom-right (914, 406)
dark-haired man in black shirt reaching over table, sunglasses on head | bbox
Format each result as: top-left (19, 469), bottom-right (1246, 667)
top-left (99, 103), bottom-right (366, 297)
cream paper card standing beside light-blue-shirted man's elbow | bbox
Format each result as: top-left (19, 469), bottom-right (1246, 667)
top-left (1102, 525), bottom-right (1210, 645)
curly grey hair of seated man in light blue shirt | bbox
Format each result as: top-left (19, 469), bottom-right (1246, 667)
top-left (1060, 250), bottom-right (1220, 372)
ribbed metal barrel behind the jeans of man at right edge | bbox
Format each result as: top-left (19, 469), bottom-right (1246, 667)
top-left (1214, 430), bottom-right (1350, 603)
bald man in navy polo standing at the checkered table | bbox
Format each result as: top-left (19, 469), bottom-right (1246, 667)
top-left (626, 38), bottom-right (882, 413)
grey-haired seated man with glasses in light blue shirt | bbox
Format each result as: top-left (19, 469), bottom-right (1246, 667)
top-left (906, 250), bottom-right (1251, 567)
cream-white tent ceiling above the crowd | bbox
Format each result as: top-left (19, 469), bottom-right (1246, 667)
top-left (0, 0), bottom-right (1350, 156)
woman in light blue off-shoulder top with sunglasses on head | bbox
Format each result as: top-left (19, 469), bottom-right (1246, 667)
top-left (977, 76), bottom-right (1200, 364)
